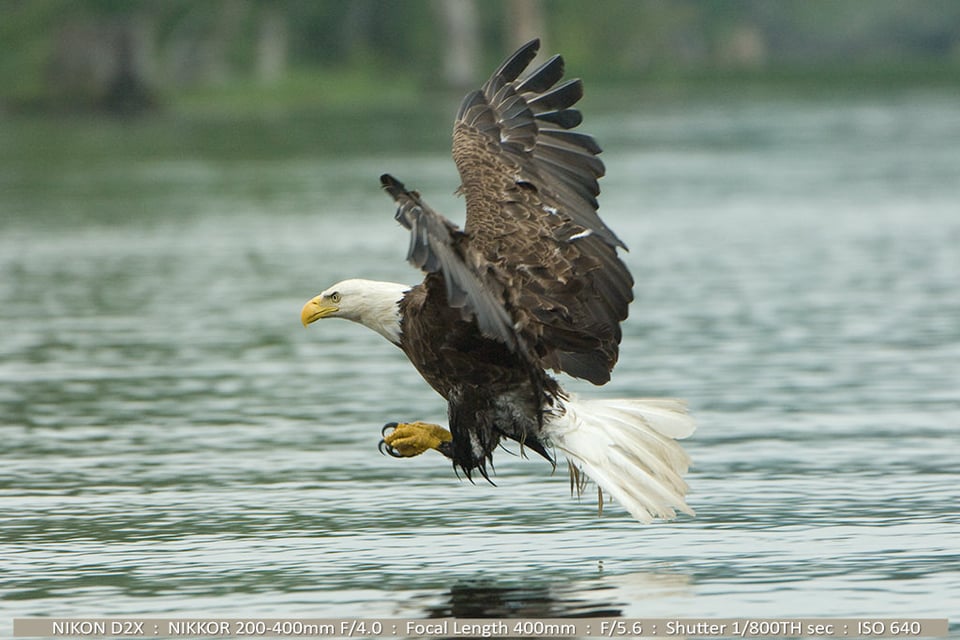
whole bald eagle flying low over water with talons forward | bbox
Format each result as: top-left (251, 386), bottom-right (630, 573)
top-left (301, 40), bottom-right (694, 523)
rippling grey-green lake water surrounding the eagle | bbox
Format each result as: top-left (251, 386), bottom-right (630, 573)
top-left (0, 91), bottom-right (960, 634)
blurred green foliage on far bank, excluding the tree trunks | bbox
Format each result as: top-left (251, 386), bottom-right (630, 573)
top-left (0, 0), bottom-right (960, 114)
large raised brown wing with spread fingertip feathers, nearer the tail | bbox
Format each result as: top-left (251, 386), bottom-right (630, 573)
top-left (453, 40), bottom-right (633, 384)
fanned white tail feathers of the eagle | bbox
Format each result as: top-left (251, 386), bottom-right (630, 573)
top-left (544, 397), bottom-right (696, 523)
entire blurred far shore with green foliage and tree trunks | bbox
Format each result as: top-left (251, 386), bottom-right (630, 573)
top-left (0, 0), bottom-right (960, 111)
